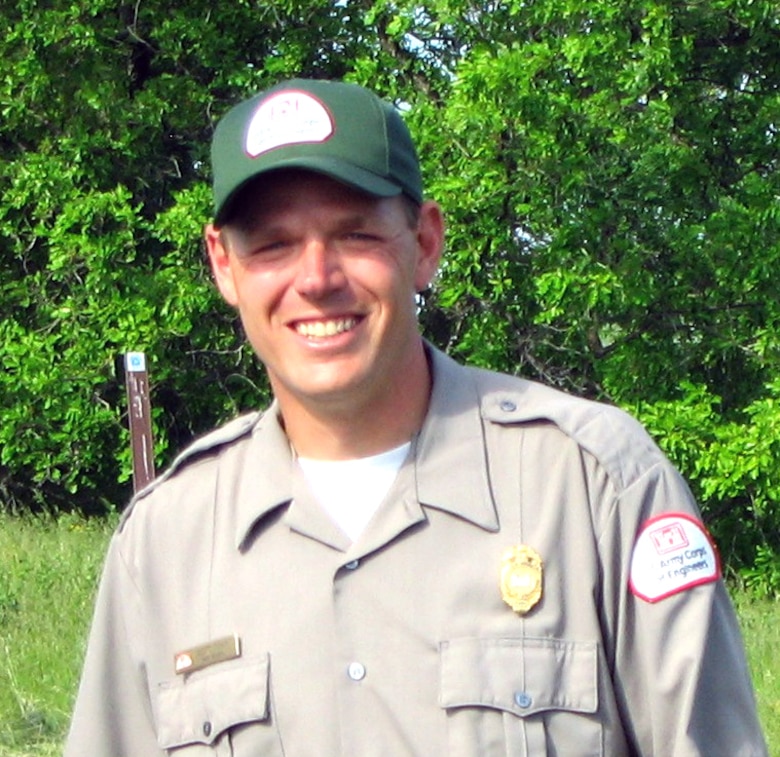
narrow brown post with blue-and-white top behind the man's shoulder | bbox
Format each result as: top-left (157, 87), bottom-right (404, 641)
top-left (124, 352), bottom-right (154, 492)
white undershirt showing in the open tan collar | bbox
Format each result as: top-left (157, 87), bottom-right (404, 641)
top-left (298, 442), bottom-right (411, 541)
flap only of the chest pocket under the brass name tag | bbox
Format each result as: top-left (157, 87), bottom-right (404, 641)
top-left (156, 656), bottom-right (268, 749)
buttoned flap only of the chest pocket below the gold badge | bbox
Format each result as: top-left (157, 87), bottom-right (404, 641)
top-left (440, 638), bottom-right (598, 717)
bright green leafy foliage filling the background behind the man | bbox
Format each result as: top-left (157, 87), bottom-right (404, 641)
top-left (0, 0), bottom-right (780, 586)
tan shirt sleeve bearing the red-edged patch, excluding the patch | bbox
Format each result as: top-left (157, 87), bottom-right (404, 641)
top-left (601, 461), bottom-right (767, 757)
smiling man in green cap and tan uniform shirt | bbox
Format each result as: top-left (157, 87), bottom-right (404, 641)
top-left (66, 80), bottom-right (766, 757)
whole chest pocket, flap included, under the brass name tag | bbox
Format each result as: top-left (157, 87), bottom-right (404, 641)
top-left (155, 657), bottom-right (282, 757)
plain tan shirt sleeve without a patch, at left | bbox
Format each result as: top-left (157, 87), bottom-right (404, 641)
top-left (64, 537), bottom-right (164, 757)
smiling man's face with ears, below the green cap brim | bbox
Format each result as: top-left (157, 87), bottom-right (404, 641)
top-left (206, 171), bottom-right (443, 416)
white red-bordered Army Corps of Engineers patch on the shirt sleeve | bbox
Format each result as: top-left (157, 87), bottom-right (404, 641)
top-left (629, 513), bottom-right (720, 602)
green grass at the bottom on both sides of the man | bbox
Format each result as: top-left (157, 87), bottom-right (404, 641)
top-left (0, 514), bottom-right (780, 757)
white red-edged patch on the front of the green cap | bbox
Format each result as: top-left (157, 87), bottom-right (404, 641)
top-left (244, 91), bottom-right (333, 158)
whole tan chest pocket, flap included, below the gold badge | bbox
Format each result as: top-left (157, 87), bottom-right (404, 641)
top-left (439, 638), bottom-right (603, 757)
